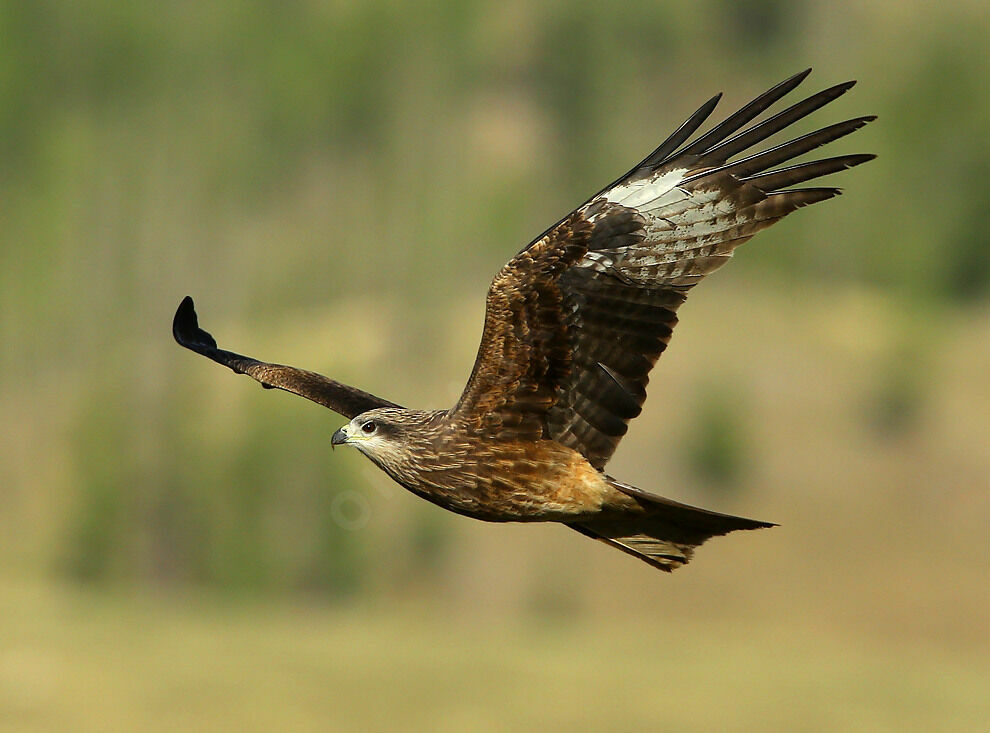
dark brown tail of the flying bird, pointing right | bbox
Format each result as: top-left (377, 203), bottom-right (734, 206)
top-left (568, 479), bottom-right (776, 573)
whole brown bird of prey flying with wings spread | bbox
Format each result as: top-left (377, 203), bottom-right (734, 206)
top-left (173, 69), bottom-right (874, 571)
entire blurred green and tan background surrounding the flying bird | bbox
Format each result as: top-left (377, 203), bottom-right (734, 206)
top-left (0, 0), bottom-right (990, 731)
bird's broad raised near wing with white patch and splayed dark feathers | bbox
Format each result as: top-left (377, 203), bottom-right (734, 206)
top-left (448, 69), bottom-right (874, 469)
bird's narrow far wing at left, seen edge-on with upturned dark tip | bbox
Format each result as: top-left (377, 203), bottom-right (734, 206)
top-left (172, 295), bottom-right (398, 418)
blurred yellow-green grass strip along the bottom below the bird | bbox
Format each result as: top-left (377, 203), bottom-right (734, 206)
top-left (0, 586), bottom-right (990, 733)
